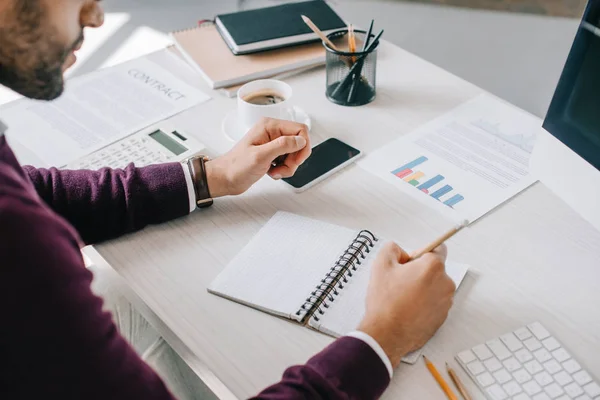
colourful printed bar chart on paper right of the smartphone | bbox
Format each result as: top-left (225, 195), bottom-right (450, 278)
top-left (392, 156), bottom-right (465, 208)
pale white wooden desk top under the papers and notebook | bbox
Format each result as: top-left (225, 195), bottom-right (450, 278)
top-left (91, 44), bottom-right (600, 400)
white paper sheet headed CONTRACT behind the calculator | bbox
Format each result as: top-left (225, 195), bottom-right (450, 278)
top-left (0, 57), bottom-right (210, 167)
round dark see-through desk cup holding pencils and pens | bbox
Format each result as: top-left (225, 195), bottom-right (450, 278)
top-left (323, 29), bottom-right (379, 107)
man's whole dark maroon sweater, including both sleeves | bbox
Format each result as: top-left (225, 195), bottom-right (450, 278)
top-left (0, 132), bottom-right (389, 400)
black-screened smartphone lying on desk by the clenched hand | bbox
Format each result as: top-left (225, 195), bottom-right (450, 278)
top-left (283, 138), bottom-right (361, 192)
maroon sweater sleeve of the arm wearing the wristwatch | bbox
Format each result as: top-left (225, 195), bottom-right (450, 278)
top-left (24, 163), bottom-right (190, 244)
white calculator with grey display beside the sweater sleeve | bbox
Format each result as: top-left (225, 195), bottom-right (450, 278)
top-left (65, 122), bottom-right (206, 170)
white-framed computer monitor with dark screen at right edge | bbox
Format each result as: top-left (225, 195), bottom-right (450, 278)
top-left (531, 0), bottom-right (600, 230)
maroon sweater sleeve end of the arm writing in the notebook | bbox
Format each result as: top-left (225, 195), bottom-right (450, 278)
top-left (254, 336), bottom-right (390, 400)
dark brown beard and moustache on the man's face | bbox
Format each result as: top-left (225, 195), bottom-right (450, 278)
top-left (0, 3), bottom-right (83, 100)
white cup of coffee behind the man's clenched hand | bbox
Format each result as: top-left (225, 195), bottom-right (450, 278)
top-left (238, 79), bottom-right (296, 134)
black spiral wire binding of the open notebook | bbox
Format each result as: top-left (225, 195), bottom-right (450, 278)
top-left (296, 230), bottom-right (379, 324)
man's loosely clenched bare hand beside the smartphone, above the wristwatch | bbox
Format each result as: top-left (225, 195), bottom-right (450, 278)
top-left (206, 118), bottom-right (311, 198)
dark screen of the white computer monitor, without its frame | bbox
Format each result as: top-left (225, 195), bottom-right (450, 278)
top-left (544, 0), bottom-right (600, 169)
